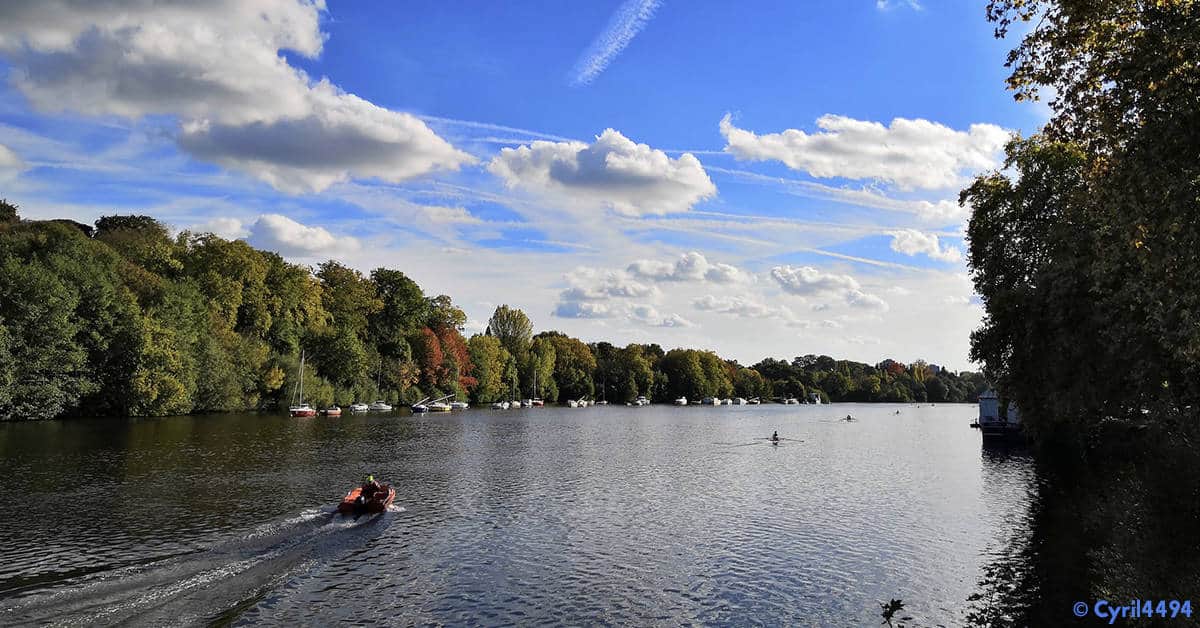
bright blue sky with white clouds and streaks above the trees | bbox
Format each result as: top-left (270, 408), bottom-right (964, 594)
top-left (0, 0), bottom-right (1046, 370)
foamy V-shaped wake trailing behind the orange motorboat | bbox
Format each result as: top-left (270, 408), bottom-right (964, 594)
top-left (0, 506), bottom-right (393, 626)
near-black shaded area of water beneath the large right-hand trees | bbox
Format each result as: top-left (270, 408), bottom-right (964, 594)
top-left (967, 433), bottom-right (1200, 627)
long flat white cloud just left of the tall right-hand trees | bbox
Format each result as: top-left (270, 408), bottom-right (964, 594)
top-left (720, 114), bottom-right (1009, 190)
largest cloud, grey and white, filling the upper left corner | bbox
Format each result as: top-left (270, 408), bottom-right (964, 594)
top-left (0, 0), bottom-right (474, 192)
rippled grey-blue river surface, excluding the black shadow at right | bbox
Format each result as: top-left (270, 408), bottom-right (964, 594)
top-left (0, 403), bottom-right (1037, 626)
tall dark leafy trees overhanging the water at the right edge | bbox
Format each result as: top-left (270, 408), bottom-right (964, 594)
top-left (961, 0), bottom-right (1200, 441)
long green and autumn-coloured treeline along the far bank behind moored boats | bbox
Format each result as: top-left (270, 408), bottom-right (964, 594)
top-left (0, 202), bottom-right (985, 420)
